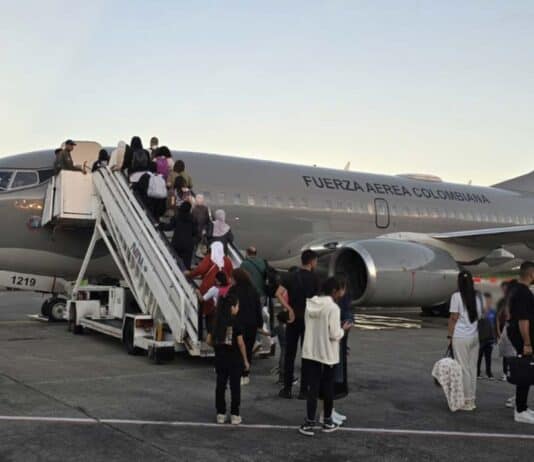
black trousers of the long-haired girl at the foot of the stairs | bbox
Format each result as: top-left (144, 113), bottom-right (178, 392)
top-left (215, 347), bottom-right (243, 415)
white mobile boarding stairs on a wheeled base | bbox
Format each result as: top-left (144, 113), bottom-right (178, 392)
top-left (43, 168), bottom-right (242, 361)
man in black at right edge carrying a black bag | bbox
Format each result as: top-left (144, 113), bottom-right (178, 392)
top-left (508, 261), bottom-right (534, 424)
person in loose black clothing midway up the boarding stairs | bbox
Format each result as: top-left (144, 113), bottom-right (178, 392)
top-left (161, 202), bottom-right (198, 270)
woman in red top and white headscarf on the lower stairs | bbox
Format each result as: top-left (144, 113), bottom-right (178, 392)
top-left (185, 242), bottom-right (234, 338)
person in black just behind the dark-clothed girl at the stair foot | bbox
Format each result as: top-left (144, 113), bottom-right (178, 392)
top-left (230, 268), bottom-right (263, 385)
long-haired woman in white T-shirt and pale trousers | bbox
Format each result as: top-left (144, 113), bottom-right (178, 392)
top-left (447, 271), bottom-right (482, 411)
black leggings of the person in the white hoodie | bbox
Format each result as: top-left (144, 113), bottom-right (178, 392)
top-left (302, 359), bottom-right (334, 422)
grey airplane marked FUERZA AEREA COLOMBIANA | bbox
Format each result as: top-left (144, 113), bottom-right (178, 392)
top-left (0, 142), bottom-right (534, 318)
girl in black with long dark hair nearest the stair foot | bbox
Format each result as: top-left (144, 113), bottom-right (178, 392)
top-left (209, 294), bottom-right (250, 425)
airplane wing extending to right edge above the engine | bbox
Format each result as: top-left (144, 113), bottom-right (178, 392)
top-left (431, 225), bottom-right (534, 248)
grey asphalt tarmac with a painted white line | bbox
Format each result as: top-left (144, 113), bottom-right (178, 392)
top-left (0, 292), bottom-right (534, 462)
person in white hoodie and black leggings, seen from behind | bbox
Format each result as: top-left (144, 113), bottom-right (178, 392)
top-left (299, 278), bottom-right (350, 436)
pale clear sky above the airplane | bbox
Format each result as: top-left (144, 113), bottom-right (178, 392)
top-left (0, 0), bottom-right (534, 185)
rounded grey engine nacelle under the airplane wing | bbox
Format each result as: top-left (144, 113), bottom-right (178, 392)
top-left (320, 239), bottom-right (459, 306)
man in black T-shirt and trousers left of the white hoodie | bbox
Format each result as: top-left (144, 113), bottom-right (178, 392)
top-left (276, 250), bottom-right (319, 399)
